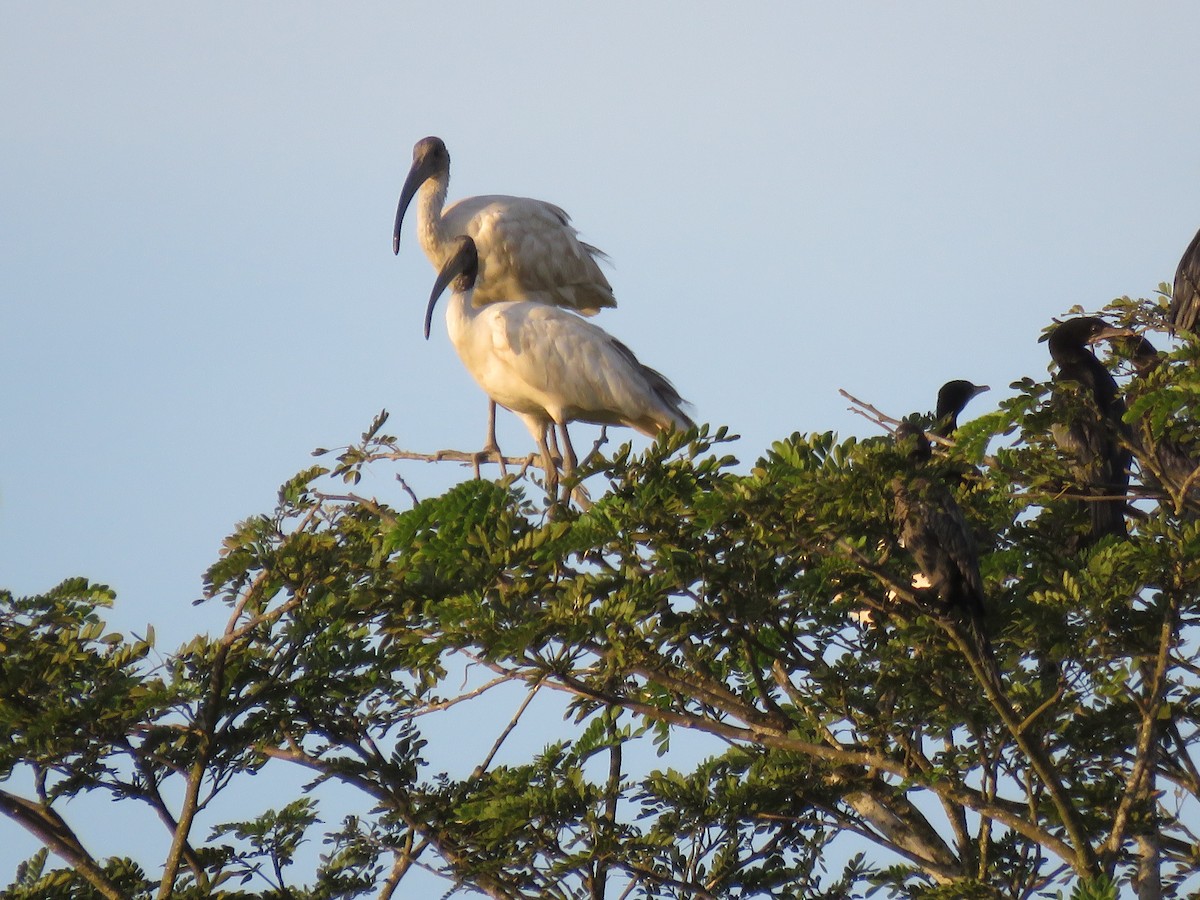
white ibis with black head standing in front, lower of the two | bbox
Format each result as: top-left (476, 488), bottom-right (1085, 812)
top-left (425, 235), bottom-right (694, 502)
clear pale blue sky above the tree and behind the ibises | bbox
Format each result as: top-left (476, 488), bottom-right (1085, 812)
top-left (0, 2), bottom-right (1200, 897)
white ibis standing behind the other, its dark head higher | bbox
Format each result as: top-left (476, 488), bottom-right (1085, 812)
top-left (391, 137), bottom-right (617, 466)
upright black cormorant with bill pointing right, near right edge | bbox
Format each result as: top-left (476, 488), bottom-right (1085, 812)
top-left (1049, 316), bottom-right (1130, 546)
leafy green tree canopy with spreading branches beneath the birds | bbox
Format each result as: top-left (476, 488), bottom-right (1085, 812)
top-left (0, 292), bottom-right (1200, 900)
